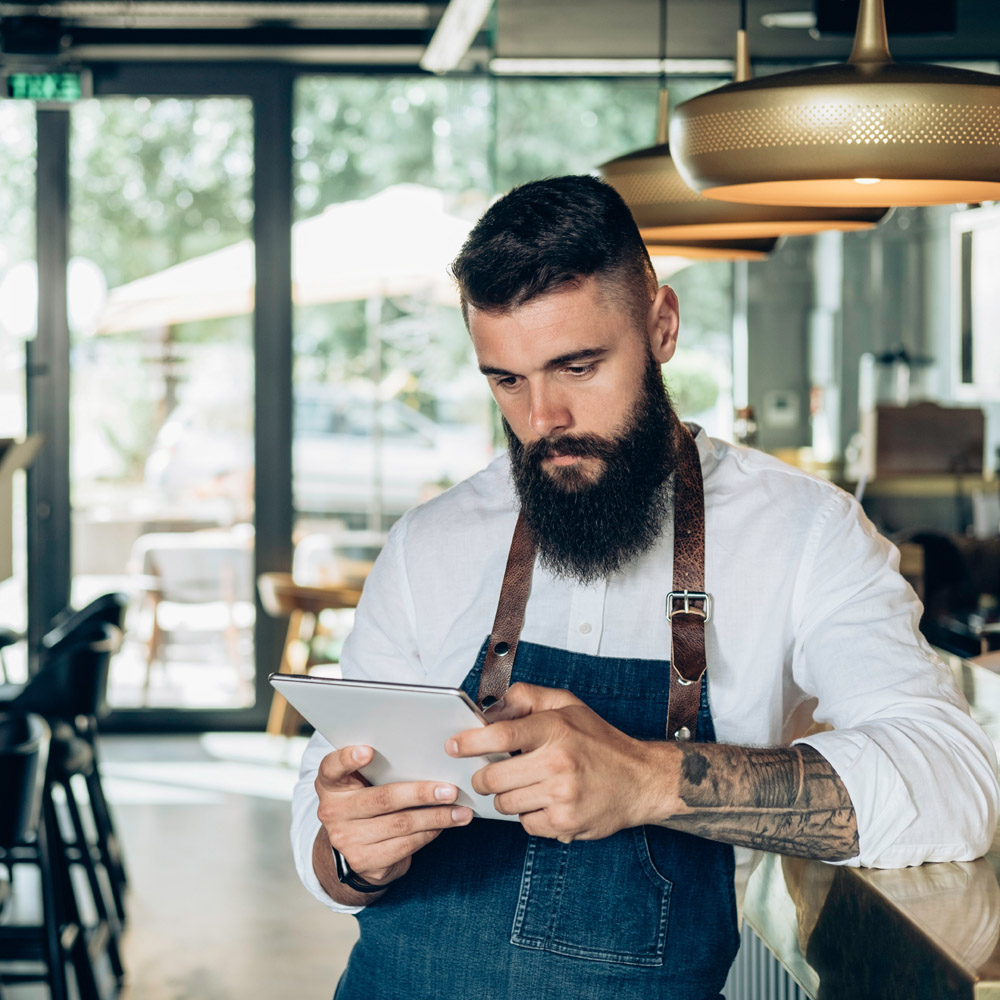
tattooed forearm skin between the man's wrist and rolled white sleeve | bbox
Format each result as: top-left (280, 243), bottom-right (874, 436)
top-left (663, 743), bottom-right (858, 861)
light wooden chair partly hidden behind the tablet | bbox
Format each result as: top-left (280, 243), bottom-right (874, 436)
top-left (257, 573), bottom-right (361, 736)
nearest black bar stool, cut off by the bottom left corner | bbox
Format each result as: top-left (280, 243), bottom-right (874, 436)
top-left (0, 712), bottom-right (100, 1000)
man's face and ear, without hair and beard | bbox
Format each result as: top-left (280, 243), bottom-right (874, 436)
top-left (469, 278), bottom-right (677, 476)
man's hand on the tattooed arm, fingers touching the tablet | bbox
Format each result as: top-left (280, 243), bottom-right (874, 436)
top-left (445, 683), bottom-right (663, 843)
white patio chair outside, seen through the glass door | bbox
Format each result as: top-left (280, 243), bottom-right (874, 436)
top-left (131, 525), bottom-right (254, 693)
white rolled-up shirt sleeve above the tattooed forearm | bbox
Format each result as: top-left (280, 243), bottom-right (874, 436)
top-left (792, 493), bottom-right (1000, 868)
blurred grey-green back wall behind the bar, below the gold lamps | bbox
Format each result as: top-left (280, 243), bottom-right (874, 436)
top-left (748, 206), bottom-right (1000, 480)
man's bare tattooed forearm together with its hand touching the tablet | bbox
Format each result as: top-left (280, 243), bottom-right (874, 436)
top-left (446, 684), bottom-right (858, 861)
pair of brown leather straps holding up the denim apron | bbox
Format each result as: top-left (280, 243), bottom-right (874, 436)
top-left (476, 418), bottom-right (711, 740)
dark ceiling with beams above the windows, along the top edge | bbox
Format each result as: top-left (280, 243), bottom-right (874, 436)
top-left (0, 0), bottom-right (1000, 72)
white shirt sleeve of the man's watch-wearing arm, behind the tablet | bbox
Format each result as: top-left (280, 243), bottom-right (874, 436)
top-left (291, 518), bottom-right (423, 913)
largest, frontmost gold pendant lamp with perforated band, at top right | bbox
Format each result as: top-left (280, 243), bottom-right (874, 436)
top-left (670, 0), bottom-right (1000, 208)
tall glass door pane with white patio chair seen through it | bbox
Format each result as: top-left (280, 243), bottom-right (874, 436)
top-left (68, 96), bottom-right (255, 710)
